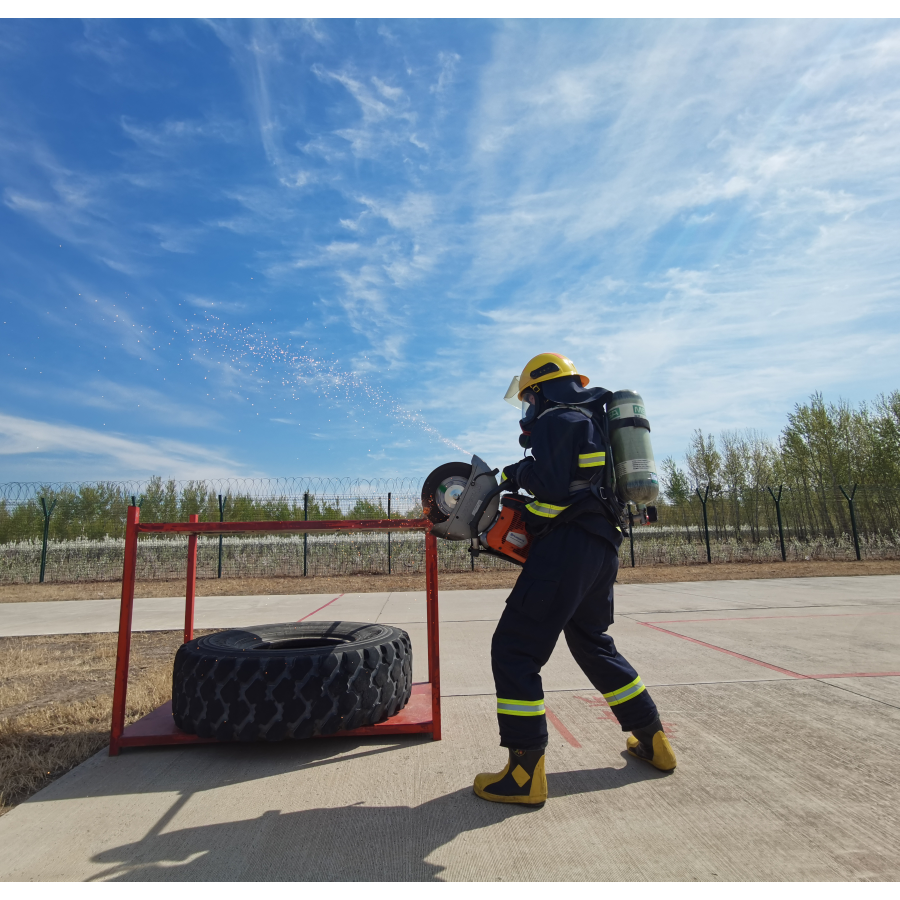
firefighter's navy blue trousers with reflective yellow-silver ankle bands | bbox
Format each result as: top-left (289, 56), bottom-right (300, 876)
top-left (491, 522), bottom-right (657, 750)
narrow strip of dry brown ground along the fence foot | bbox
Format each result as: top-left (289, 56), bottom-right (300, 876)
top-left (0, 559), bottom-right (900, 603)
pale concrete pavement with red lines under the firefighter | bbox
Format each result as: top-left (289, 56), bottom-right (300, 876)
top-left (0, 576), bottom-right (900, 881)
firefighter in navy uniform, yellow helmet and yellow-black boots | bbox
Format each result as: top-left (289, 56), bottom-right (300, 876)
top-left (475, 353), bottom-right (675, 805)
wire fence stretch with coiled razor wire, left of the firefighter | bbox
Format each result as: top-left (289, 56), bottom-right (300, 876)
top-left (0, 478), bottom-right (516, 584)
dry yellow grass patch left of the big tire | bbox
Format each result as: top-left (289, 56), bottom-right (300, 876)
top-left (0, 631), bottom-right (205, 815)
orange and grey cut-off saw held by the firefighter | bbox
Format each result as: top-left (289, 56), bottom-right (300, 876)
top-left (422, 456), bottom-right (532, 566)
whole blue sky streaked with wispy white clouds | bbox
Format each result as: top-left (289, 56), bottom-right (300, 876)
top-left (0, 20), bottom-right (900, 481)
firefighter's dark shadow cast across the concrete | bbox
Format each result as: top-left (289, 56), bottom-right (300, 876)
top-left (86, 760), bottom-right (661, 882)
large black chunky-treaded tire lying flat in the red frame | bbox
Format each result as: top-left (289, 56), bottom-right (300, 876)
top-left (172, 622), bottom-right (412, 741)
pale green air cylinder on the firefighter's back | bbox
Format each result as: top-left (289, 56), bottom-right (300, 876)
top-left (606, 391), bottom-right (659, 506)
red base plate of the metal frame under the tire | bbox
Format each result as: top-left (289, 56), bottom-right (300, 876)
top-left (119, 682), bottom-right (434, 747)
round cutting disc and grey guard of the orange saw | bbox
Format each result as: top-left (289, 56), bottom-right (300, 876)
top-left (422, 456), bottom-right (500, 541)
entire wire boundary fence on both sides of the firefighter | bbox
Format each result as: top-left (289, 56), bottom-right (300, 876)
top-left (0, 478), bottom-right (900, 584)
